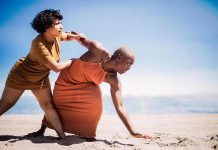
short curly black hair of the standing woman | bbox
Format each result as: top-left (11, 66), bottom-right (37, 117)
top-left (31, 9), bottom-right (63, 33)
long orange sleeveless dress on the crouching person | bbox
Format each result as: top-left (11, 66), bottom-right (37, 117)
top-left (53, 59), bottom-right (106, 137)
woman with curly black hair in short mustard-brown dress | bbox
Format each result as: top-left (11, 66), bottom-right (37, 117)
top-left (0, 9), bottom-right (82, 138)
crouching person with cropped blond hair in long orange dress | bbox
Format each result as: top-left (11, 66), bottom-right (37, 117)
top-left (30, 32), bottom-right (152, 139)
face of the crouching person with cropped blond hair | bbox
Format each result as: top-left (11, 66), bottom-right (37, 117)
top-left (117, 57), bottom-right (134, 74)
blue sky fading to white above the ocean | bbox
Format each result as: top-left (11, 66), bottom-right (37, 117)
top-left (0, 0), bottom-right (218, 96)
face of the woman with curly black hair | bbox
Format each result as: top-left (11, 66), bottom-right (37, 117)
top-left (46, 19), bottom-right (63, 37)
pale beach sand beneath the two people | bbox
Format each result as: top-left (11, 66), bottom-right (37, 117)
top-left (0, 114), bottom-right (218, 150)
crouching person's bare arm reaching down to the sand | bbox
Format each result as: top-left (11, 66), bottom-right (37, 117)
top-left (106, 76), bottom-right (151, 138)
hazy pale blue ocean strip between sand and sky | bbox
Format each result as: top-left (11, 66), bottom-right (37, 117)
top-left (3, 96), bottom-right (218, 114)
